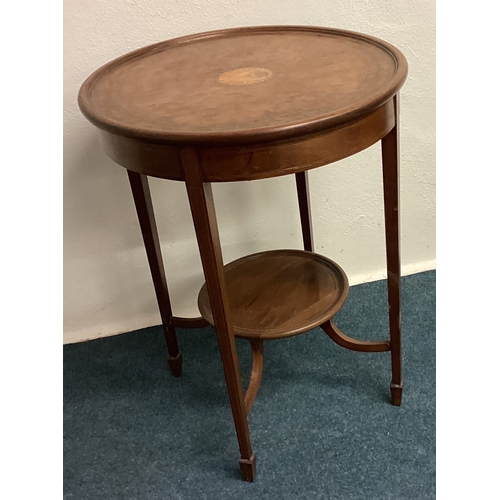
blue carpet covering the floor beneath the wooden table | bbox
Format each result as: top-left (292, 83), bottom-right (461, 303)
top-left (64, 271), bottom-right (436, 500)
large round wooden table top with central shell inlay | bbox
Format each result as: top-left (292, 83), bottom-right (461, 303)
top-left (78, 26), bottom-right (407, 145)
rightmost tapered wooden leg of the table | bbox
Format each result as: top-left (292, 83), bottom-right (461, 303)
top-left (382, 95), bottom-right (403, 406)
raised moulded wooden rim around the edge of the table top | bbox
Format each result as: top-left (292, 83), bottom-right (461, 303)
top-left (78, 25), bottom-right (408, 146)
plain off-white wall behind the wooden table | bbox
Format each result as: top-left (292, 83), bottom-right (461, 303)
top-left (64, 0), bottom-right (435, 342)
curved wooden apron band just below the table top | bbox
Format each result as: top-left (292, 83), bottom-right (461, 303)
top-left (100, 98), bottom-right (395, 182)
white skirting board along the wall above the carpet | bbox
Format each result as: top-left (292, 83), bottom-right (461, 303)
top-left (63, 259), bottom-right (436, 344)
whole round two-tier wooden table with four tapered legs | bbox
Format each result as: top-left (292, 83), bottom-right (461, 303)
top-left (78, 26), bottom-right (407, 481)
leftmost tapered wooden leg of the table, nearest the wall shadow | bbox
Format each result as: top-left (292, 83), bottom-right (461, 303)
top-left (127, 170), bottom-right (182, 377)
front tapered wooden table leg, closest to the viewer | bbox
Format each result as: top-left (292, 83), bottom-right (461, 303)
top-left (182, 150), bottom-right (256, 481)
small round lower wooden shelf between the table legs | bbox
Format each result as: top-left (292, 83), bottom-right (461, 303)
top-left (198, 250), bottom-right (349, 340)
